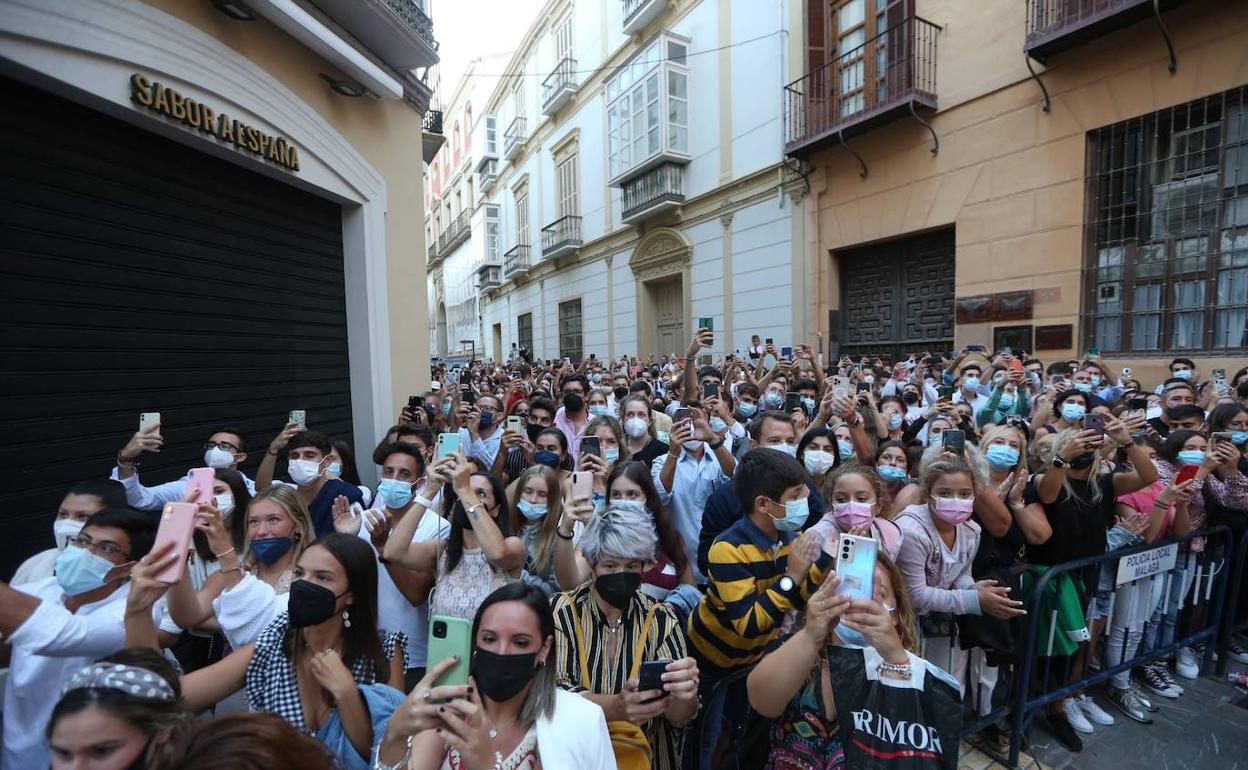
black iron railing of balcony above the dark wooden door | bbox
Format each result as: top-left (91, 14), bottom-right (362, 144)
top-left (785, 16), bottom-right (940, 155)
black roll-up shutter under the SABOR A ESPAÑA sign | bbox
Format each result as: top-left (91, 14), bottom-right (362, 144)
top-left (0, 77), bottom-right (351, 575)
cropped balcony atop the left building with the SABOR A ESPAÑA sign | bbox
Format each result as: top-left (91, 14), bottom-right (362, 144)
top-left (311, 0), bottom-right (438, 71)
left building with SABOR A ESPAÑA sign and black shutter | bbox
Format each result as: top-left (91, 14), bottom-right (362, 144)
top-left (0, 0), bottom-right (437, 574)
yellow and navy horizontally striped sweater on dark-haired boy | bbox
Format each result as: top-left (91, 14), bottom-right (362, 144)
top-left (688, 517), bottom-right (832, 671)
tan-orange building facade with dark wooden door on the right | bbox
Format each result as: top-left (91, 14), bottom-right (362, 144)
top-left (784, 0), bottom-right (1248, 381)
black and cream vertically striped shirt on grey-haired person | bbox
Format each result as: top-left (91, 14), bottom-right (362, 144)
top-left (550, 582), bottom-right (689, 770)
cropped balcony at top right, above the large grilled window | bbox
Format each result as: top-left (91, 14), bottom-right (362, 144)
top-left (1023, 0), bottom-right (1184, 64)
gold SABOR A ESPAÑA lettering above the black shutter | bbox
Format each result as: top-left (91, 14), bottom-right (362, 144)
top-left (130, 72), bottom-right (300, 171)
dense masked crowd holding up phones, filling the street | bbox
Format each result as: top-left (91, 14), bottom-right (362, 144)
top-left (0, 328), bottom-right (1248, 770)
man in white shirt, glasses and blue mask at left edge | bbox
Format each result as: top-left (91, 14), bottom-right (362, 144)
top-left (0, 508), bottom-right (156, 769)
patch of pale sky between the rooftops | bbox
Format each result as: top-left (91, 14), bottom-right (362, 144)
top-left (431, 0), bottom-right (543, 97)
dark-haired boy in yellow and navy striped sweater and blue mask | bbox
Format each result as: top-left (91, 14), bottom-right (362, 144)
top-left (686, 449), bottom-right (832, 769)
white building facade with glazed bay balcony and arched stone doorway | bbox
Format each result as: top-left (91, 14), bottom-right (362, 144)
top-left (432, 0), bottom-right (805, 361)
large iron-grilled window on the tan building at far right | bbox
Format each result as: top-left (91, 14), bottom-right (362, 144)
top-left (1083, 87), bottom-right (1248, 354)
